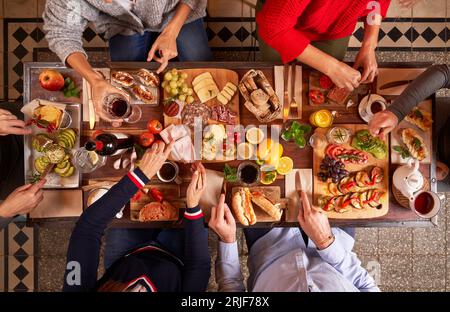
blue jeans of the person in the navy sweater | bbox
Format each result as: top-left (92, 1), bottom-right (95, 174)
top-left (104, 228), bottom-right (186, 270)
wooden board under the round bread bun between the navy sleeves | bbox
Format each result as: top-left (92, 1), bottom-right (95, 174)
top-left (130, 184), bottom-right (186, 221)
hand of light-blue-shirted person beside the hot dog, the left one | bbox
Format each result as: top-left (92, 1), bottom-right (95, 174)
top-left (208, 194), bottom-right (236, 243)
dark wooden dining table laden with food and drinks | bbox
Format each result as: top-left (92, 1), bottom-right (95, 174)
top-left (24, 62), bottom-right (437, 227)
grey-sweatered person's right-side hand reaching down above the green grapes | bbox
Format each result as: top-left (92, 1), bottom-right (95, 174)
top-left (147, 29), bottom-right (178, 74)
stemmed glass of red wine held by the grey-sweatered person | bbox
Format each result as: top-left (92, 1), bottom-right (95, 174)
top-left (103, 93), bottom-right (142, 123)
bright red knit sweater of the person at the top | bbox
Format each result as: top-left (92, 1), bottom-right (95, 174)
top-left (256, 0), bottom-right (391, 63)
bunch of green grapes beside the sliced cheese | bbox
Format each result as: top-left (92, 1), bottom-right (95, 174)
top-left (162, 68), bottom-right (194, 104)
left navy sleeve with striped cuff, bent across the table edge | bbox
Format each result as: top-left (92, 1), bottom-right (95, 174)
top-left (63, 168), bottom-right (149, 291)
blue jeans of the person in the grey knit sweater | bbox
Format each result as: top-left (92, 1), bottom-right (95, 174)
top-left (109, 18), bottom-right (212, 62)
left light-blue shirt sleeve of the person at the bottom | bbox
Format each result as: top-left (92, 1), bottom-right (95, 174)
top-left (216, 241), bottom-right (245, 292)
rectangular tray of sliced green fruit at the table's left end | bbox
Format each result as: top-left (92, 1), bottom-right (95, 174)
top-left (24, 103), bottom-right (82, 189)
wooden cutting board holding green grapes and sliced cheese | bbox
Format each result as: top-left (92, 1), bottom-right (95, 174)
top-left (163, 68), bottom-right (239, 127)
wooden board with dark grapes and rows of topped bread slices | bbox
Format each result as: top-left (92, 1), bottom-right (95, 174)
top-left (313, 124), bottom-right (389, 219)
